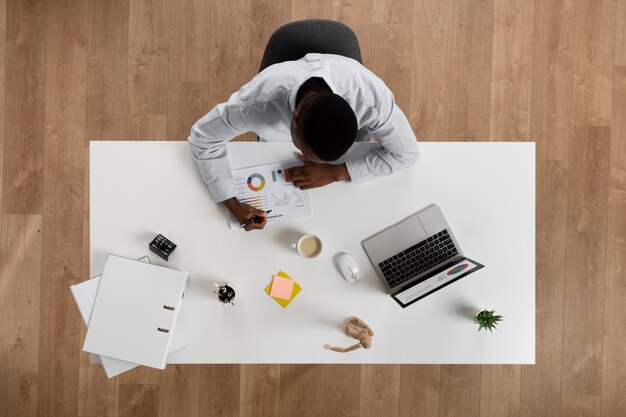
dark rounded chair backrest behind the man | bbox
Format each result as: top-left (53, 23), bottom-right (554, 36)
top-left (259, 19), bottom-right (361, 72)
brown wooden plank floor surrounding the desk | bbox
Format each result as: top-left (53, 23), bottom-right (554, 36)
top-left (0, 0), bottom-right (626, 417)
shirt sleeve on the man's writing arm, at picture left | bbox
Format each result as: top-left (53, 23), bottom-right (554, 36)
top-left (188, 92), bottom-right (249, 203)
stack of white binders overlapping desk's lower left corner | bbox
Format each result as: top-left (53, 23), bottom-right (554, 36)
top-left (71, 255), bottom-right (189, 378)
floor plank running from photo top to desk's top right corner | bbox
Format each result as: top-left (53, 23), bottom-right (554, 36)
top-left (489, 0), bottom-right (534, 141)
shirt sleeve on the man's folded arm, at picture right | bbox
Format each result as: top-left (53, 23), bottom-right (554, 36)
top-left (346, 92), bottom-right (420, 183)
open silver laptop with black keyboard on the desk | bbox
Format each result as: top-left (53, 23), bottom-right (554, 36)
top-left (362, 204), bottom-right (482, 307)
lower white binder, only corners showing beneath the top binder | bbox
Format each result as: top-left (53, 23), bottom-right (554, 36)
top-left (70, 259), bottom-right (187, 378)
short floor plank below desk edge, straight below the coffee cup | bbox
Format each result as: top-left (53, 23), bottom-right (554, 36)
top-left (279, 364), bottom-right (322, 417)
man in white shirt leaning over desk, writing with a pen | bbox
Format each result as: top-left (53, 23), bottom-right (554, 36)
top-left (189, 54), bottom-right (419, 231)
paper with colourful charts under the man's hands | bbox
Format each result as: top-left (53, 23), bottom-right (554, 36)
top-left (228, 162), bottom-right (313, 229)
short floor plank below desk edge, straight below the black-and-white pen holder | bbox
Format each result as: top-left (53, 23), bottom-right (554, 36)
top-left (198, 365), bottom-right (241, 417)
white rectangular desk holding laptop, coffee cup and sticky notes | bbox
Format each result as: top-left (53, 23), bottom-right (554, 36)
top-left (90, 142), bottom-right (535, 364)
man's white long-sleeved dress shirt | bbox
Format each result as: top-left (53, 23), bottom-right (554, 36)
top-left (189, 54), bottom-right (419, 202)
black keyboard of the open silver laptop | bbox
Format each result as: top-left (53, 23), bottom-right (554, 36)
top-left (378, 229), bottom-right (458, 288)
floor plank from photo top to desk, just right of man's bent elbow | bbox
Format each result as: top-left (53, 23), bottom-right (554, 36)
top-left (407, 0), bottom-right (454, 141)
